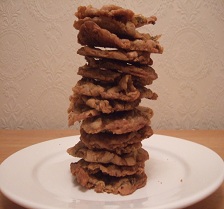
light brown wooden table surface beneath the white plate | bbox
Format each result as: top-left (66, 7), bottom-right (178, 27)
top-left (0, 130), bottom-right (224, 209)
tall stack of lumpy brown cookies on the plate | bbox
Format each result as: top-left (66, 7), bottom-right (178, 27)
top-left (67, 5), bottom-right (163, 195)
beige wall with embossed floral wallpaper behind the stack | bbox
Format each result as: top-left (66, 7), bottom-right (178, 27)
top-left (0, 0), bottom-right (224, 129)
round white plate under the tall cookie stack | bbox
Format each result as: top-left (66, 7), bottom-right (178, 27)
top-left (0, 135), bottom-right (224, 209)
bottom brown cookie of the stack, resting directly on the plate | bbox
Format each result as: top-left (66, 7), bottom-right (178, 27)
top-left (71, 163), bottom-right (147, 195)
